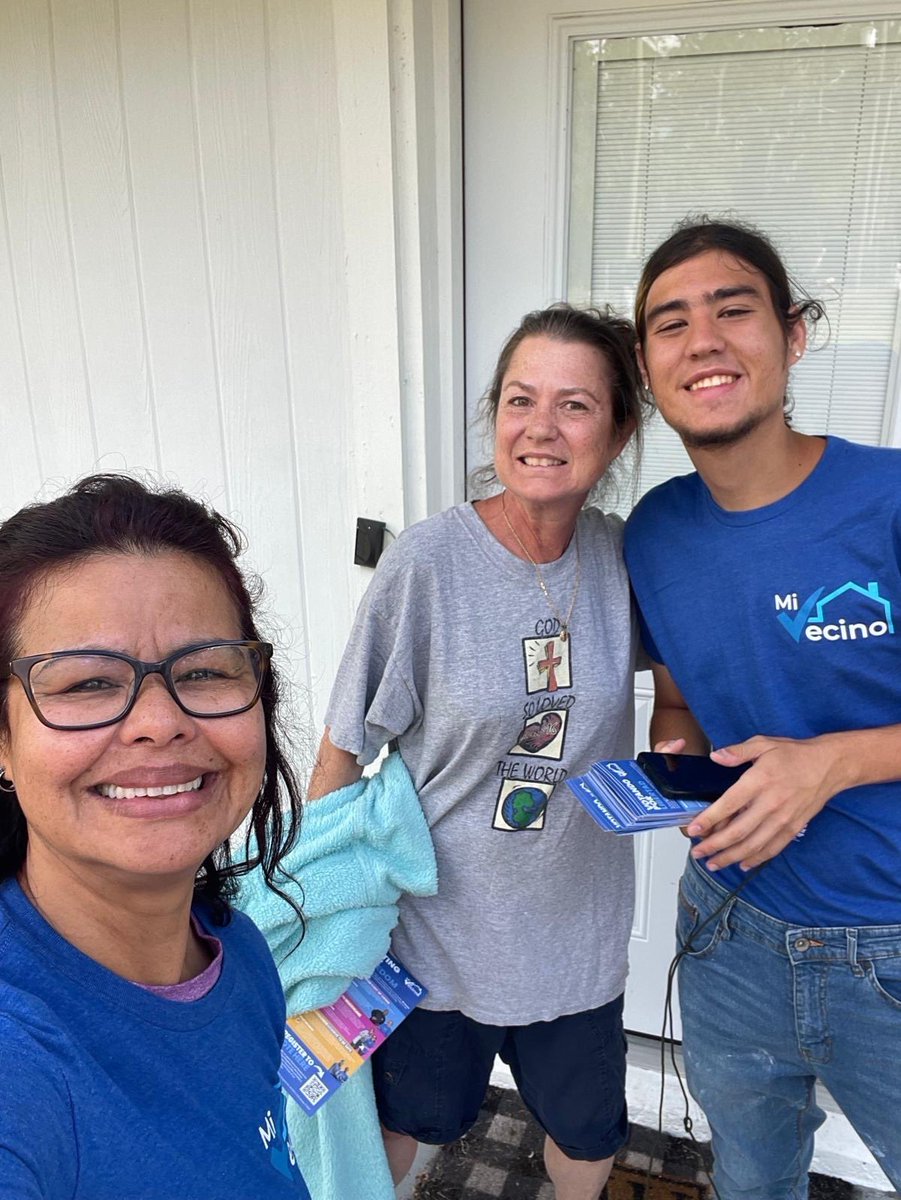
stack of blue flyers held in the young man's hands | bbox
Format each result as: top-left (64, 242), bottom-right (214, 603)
top-left (566, 758), bottom-right (707, 833)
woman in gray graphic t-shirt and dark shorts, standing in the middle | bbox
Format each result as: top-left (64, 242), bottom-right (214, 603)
top-left (310, 305), bottom-right (644, 1200)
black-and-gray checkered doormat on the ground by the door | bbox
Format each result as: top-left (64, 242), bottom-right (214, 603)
top-left (413, 1087), bottom-right (887, 1200)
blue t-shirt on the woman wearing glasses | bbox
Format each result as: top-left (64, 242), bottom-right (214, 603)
top-left (0, 880), bottom-right (310, 1200)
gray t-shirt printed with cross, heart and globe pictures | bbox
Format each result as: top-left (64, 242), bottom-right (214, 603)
top-left (326, 504), bottom-right (637, 1025)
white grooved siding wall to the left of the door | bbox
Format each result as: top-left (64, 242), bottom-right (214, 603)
top-left (0, 0), bottom-right (463, 758)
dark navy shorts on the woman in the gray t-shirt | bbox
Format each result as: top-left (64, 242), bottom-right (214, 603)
top-left (372, 996), bottom-right (629, 1162)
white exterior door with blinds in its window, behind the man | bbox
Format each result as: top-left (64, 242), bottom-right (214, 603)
top-left (463, 0), bottom-right (901, 1036)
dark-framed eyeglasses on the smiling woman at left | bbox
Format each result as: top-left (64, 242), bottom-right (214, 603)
top-left (0, 641), bottom-right (272, 730)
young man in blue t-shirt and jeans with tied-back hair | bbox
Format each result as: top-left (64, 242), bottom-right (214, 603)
top-left (625, 222), bottom-right (901, 1200)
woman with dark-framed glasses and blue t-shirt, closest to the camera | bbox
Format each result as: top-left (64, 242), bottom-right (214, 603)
top-left (0, 475), bottom-right (308, 1200)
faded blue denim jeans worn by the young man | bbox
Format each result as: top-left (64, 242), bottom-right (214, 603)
top-left (677, 860), bottom-right (901, 1200)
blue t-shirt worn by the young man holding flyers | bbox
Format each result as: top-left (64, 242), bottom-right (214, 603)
top-left (625, 438), bottom-right (901, 926)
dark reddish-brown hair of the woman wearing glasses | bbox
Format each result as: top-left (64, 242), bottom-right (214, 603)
top-left (0, 475), bottom-right (301, 924)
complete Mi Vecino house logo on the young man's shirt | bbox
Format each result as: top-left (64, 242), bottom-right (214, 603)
top-left (773, 581), bottom-right (895, 642)
